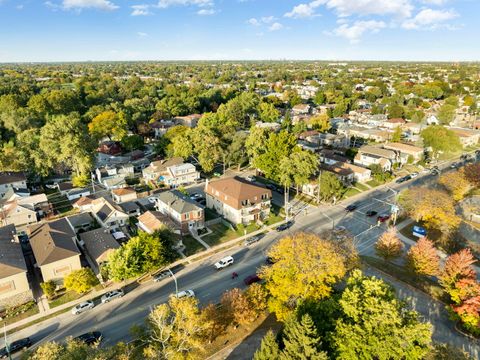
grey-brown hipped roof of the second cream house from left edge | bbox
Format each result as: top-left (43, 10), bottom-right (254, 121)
top-left (28, 219), bottom-right (80, 266)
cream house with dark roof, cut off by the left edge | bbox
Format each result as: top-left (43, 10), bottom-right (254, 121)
top-left (0, 225), bottom-right (33, 308)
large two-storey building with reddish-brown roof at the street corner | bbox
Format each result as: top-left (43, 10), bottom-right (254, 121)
top-left (205, 177), bottom-right (272, 224)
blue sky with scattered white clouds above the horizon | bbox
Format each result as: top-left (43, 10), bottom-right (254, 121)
top-left (0, 0), bottom-right (480, 62)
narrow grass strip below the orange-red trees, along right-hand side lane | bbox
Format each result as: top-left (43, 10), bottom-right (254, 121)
top-left (360, 255), bottom-right (448, 302)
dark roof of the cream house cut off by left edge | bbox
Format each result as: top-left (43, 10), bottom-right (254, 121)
top-left (0, 224), bottom-right (27, 279)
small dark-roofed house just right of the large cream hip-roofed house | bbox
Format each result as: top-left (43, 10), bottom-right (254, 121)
top-left (79, 228), bottom-right (120, 268)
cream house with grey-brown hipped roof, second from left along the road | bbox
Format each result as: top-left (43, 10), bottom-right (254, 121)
top-left (28, 219), bottom-right (82, 284)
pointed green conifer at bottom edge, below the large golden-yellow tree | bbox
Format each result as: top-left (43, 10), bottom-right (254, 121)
top-left (280, 314), bottom-right (328, 360)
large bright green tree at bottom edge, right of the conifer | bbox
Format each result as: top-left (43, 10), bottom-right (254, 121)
top-left (331, 270), bottom-right (432, 360)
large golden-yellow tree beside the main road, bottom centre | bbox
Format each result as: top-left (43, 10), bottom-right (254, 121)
top-left (260, 233), bottom-right (348, 320)
